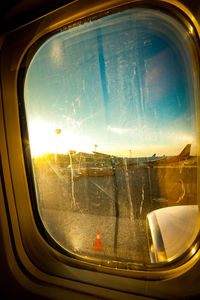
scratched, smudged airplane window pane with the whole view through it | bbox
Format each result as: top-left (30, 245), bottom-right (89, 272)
top-left (24, 8), bottom-right (199, 268)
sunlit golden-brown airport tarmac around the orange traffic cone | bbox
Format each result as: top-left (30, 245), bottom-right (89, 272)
top-left (32, 158), bottom-right (197, 263)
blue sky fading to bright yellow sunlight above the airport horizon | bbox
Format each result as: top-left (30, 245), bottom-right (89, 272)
top-left (24, 9), bottom-right (197, 157)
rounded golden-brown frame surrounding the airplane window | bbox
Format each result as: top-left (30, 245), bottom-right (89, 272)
top-left (0, 0), bottom-right (200, 299)
